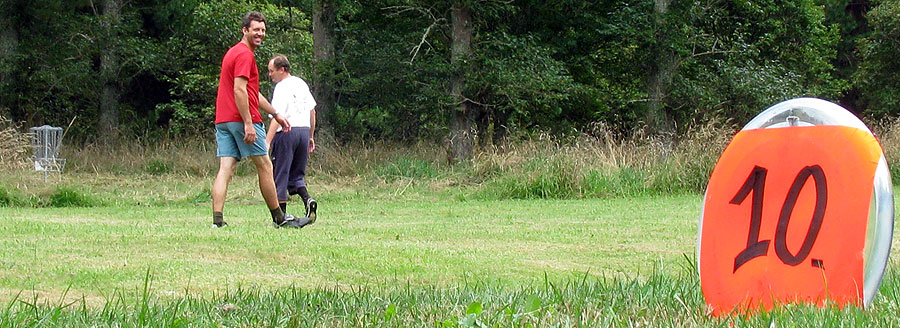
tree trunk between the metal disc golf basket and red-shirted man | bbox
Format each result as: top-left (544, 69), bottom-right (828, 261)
top-left (100, 0), bottom-right (122, 135)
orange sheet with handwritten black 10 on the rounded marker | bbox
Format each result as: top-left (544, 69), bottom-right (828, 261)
top-left (699, 125), bottom-right (881, 315)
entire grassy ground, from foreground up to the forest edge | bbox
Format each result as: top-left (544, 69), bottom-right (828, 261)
top-left (0, 123), bottom-right (900, 327)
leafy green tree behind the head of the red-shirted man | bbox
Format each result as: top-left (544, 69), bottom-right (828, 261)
top-left (154, 1), bottom-right (313, 132)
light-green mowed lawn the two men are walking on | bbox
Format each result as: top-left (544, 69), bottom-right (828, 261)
top-left (0, 190), bottom-right (699, 304)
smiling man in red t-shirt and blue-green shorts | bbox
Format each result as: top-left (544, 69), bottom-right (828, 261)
top-left (212, 11), bottom-right (308, 228)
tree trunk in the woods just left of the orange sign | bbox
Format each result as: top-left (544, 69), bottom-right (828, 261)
top-left (645, 0), bottom-right (675, 136)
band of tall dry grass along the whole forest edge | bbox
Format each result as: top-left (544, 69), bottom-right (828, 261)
top-left (8, 119), bottom-right (900, 205)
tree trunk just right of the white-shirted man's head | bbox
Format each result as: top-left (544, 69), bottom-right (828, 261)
top-left (312, 0), bottom-right (337, 127)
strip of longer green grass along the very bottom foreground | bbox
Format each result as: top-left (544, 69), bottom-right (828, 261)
top-left (0, 267), bottom-right (900, 328)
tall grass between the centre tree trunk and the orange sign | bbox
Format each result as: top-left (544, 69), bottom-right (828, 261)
top-left (472, 122), bottom-right (736, 199)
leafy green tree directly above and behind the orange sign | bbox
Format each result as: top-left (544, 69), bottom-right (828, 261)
top-left (667, 0), bottom-right (847, 123)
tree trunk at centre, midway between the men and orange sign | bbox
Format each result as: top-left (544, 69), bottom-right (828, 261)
top-left (450, 1), bottom-right (476, 162)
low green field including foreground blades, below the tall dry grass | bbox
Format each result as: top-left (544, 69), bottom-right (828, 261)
top-left (0, 174), bottom-right (900, 327)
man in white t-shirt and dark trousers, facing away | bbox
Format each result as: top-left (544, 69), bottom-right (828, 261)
top-left (266, 55), bottom-right (318, 225)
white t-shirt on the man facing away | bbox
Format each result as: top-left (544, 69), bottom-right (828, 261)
top-left (272, 75), bottom-right (316, 131)
